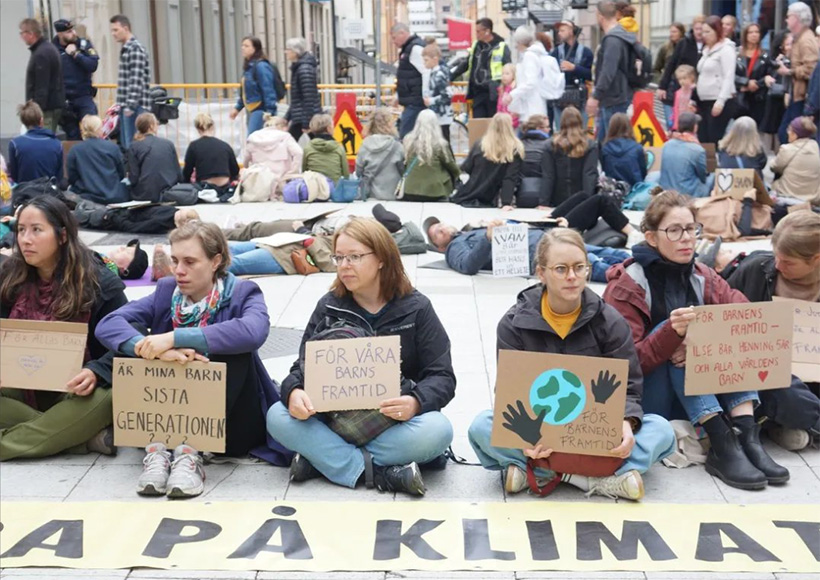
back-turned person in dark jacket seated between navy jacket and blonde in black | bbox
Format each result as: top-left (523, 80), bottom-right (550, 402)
top-left (128, 113), bottom-right (182, 202)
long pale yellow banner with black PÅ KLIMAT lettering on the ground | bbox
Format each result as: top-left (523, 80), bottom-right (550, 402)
top-left (0, 500), bottom-right (820, 572)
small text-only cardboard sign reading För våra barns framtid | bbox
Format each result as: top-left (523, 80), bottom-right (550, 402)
top-left (305, 336), bottom-right (401, 412)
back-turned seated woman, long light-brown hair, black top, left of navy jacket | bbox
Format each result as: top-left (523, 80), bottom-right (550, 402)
top-left (541, 107), bottom-right (598, 207)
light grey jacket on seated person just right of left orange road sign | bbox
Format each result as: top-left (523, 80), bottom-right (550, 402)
top-left (356, 135), bottom-right (404, 201)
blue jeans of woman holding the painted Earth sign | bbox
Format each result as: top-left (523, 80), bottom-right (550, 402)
top-left (467, 409), bottom-right (675, 477)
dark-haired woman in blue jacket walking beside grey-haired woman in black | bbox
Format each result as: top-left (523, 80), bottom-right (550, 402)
top-left (230, 36), bottom-right (285, 136)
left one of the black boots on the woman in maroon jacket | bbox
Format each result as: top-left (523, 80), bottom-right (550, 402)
top-left (703, 415), bottom-right (767, 489)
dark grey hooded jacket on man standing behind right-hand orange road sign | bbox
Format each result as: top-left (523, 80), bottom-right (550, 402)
top-left (592, 24), bottom-right (637, 107)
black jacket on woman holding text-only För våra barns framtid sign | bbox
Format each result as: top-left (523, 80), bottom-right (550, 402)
top-left (281, 290), bottom-right (456, 413)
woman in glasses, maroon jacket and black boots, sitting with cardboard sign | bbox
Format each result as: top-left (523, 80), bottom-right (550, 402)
top-left (604, 191), bottom-right (789, 489)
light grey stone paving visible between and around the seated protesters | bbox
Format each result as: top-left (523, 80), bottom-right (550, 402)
top-left (0, 202), bottom-right (820, 580)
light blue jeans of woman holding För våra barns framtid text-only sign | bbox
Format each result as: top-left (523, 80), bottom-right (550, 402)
top-left (267, 401), bottom-right (453, 488)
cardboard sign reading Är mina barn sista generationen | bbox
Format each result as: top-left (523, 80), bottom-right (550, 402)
top-left (113, 358), bottom-right (227, 453)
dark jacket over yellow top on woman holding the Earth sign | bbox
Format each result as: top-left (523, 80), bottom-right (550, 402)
top-left (496, 284), bottom-right (643, 430)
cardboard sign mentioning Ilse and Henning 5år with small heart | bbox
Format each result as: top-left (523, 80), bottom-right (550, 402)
top-left (684, 302), bottom-right (794, 395)
